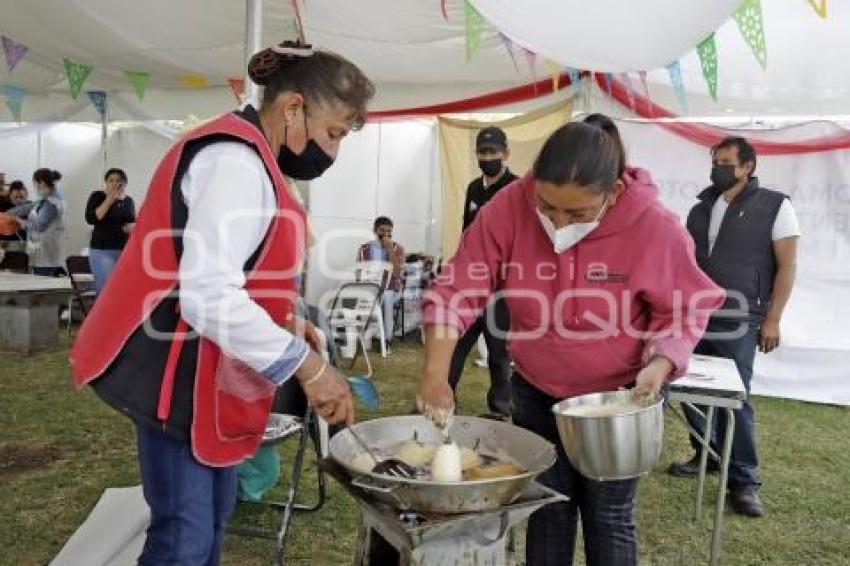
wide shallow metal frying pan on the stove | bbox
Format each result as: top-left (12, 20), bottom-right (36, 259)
top-left (329, 415), bottom-right (555, 513)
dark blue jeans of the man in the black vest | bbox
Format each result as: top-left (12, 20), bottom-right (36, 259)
top-left (684, 319), bottom-right (761, 488)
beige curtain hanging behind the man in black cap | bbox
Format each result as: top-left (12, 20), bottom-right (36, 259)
top-left (439, 99), bottom-right (573, 258)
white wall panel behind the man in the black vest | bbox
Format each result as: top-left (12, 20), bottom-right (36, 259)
top-left (618, 121), bottom-right (850, 405)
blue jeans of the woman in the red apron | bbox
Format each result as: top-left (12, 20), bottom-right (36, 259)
top-left (136, 424), bottom-right (236, 566)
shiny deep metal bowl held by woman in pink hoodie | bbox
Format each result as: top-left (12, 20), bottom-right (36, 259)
top-left (552, 391), bottom-right (664, 481)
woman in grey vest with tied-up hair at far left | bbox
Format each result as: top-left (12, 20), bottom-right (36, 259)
top-left (8, 169), bottom-right (65, 277)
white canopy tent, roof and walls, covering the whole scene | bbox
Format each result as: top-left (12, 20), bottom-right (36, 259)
top-left (0, 0), bottom-right (850, 404)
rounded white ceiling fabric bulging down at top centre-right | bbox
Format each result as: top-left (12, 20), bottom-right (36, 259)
top-left (471, 0), bottom-right (741, 72)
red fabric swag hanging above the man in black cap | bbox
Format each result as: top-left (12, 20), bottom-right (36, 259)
top-left (369, 74), bottom-right (570, 120)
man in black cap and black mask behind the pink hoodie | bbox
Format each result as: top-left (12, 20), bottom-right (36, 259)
top-left (449, 126), bottom-right (517, 419)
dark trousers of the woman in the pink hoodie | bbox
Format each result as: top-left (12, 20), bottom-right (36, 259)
top-left (512, 374), bottom-right (638, 566)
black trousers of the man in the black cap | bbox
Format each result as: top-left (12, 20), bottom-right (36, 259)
top-left (449, 300), bottom-right (511, 416)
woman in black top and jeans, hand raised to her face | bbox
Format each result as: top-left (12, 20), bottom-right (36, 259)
top-left (86, 168), bottom-right (136, 293)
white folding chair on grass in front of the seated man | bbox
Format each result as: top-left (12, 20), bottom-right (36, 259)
top-left (328, 283), bottom-right (386, 366)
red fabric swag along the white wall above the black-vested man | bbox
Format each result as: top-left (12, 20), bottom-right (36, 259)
top-left (595, 73), bottom-right (850, 155)
